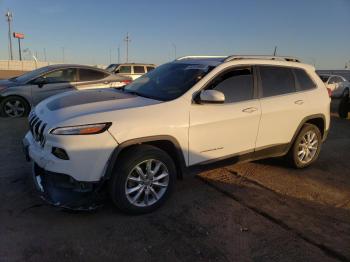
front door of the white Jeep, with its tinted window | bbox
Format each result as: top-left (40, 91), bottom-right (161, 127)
top-left (189, 67), bottom-right (261, 165)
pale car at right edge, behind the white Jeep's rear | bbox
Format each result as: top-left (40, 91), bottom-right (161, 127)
top-left (320, 74), bottom-right (350, 98)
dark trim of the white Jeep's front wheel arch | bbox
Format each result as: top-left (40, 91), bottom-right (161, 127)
top-left (104, 135), bottom-right (186, 180)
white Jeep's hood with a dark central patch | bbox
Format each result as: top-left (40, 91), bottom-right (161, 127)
top-left (35, 88), bottom-right (161, 124)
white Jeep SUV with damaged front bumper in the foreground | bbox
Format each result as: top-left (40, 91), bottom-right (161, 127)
top-left (23, 56), bottom-right (330, 213)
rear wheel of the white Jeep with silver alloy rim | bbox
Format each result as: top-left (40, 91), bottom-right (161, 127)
top-left (287, 124), bottom-right (322, 168)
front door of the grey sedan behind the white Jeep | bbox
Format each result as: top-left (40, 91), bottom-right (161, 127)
top-left (31, 68), bottom-right (77, 104)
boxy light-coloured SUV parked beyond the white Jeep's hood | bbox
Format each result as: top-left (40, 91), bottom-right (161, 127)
top-left (106, 63), bottom-right (156, 80)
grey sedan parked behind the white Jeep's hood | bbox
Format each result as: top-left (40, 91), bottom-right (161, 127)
top-left (0, 65), bottom-right (132, 117)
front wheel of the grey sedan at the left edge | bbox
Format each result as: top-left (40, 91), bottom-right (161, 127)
top-left (0, 96), bottom-right (30, 118)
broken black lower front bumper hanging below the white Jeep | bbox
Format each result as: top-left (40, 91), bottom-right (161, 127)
top-left (32, 162), bottom-right (104, 211)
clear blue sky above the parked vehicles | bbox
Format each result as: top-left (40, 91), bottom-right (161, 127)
top-left (0, 0), bottom-right (350, 69)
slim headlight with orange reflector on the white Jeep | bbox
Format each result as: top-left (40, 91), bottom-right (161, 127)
top-left (50, 123), bottom-right (112, 135)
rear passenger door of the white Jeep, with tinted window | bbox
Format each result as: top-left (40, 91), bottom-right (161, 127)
top-left (256, 66), bottom-right (309, 150)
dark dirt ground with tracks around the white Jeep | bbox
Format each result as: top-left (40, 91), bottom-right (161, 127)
top-left (0, 101), bottom-right (350, 261)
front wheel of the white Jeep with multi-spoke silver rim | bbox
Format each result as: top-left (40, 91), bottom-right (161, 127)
top-left (109, 145), bottom-right (176, 214)
